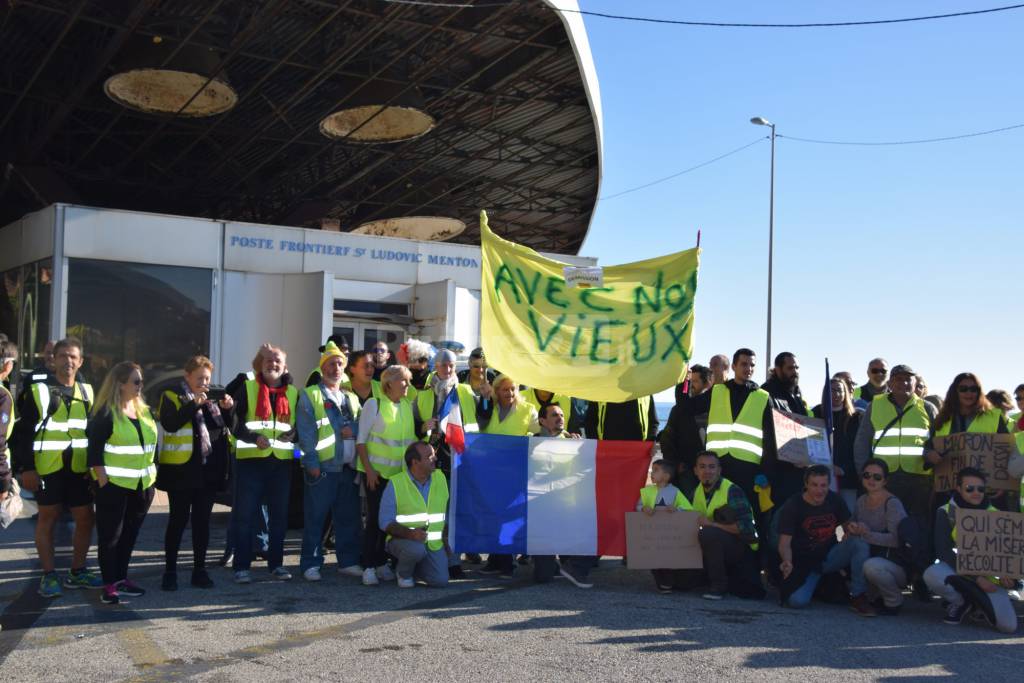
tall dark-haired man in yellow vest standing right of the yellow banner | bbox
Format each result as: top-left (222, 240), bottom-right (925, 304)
top-left (678, 348), bottom-right (776, 515)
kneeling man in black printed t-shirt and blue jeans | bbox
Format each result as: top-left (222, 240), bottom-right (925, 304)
top-left (778, 465), bottom-right (876, 616)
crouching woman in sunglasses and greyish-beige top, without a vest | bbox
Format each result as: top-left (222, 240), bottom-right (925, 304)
top-left (848, 458), bottom-right (908, 616)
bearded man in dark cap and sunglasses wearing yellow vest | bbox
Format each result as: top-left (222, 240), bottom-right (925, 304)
top-left (853, 365), bottom-right (938, 528)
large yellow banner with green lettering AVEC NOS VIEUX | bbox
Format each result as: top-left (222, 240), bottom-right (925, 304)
top-left (480, 212), bottom-right (700, 401)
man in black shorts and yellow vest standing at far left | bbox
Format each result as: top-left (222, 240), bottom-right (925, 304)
top-left (12, 337), bottom-right (102, 598)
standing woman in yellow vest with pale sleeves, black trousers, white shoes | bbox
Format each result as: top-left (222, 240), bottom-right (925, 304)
top-left (355, 366), bottom-right (417, 586)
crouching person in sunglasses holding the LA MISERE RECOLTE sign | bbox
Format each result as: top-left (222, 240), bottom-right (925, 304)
top-left (925, 467), bottom-right (1017, 633)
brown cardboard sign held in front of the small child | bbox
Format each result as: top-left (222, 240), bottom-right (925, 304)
top-left (626, 510), bottom-right (703, 569)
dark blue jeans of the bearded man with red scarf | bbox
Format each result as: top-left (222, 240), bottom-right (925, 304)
top-left (231, 456), bottom-right (292, 571)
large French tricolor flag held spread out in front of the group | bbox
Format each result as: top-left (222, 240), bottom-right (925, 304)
top-left (449, 434), bottom-right (653, 556)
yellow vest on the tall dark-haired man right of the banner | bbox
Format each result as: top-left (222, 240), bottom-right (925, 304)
top-left (706, 384), bottom-right (771, 465)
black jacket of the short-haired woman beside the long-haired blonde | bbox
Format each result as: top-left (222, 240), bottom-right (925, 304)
top-left (157, 386), bottom-right (230, 490)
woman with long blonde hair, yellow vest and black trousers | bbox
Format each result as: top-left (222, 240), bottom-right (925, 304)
top-left (86, 360), bottom-right (157, 604)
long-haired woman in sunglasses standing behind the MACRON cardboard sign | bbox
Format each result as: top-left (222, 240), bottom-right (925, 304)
top-left (925, 373), bottom-right (1019, 512)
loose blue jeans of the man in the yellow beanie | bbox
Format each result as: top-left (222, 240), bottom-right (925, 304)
top-left (299, 466), bottom-right (362, 571)
